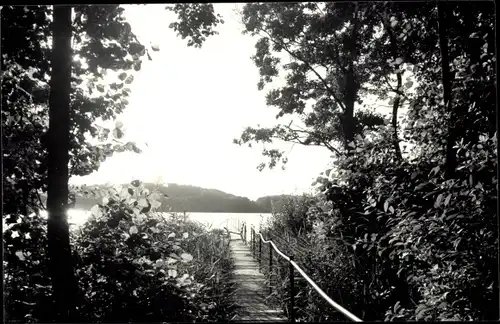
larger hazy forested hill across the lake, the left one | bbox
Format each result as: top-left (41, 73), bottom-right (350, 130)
top-left (75, 183), bottom-right (271, 213)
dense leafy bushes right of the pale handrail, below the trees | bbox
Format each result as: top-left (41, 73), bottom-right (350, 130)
top-left (260, 128), bottom-right (498, 321)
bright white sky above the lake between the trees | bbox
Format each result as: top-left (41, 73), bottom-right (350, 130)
top-left (72, 4), bottom-right (406, 199)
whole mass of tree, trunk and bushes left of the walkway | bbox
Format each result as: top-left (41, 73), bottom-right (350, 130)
top-left (1, 3), bottom-right (238, 323)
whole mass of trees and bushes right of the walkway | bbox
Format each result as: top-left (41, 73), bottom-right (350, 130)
top-left (236, 1), bottom-right (499, 321)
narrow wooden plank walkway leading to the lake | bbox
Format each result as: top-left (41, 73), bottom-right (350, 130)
top-left (229, 233), bottom-right (288, 322)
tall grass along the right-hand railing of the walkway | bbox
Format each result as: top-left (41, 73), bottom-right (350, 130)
top-left (252, 196), bottom-right (352, 322)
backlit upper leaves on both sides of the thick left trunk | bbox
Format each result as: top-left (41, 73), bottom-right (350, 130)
top-left (2, 5), bottom-right (145, 221)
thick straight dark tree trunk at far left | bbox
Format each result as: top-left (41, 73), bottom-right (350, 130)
top-left (47, 5), bottom-right (76, 322)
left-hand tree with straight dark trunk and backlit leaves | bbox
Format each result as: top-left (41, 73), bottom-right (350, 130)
top-left (1, 4), bottom-right (223, 322)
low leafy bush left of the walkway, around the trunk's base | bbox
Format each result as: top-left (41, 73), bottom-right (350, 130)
top-left (4, 182), bottom-right (232, 322)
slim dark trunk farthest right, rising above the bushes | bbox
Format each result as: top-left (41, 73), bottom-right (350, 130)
top-left (437, 1), bottom-right (457, 179)
